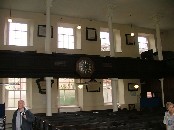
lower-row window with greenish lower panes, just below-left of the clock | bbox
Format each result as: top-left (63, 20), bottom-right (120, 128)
top-left (58, 78), bottom-right (76, 106)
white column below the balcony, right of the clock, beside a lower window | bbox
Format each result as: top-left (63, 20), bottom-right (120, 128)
top-left (111, 78), bottom-right (118, 112)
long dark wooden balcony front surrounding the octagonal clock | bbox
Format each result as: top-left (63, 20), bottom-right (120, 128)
top-left (0, 51), bottom-right (165, 79)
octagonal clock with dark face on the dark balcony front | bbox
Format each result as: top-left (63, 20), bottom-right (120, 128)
top-left (76, 57), bottom-right (94, 77)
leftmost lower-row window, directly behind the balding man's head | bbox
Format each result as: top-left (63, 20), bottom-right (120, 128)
top-left (5, 78), bottom-right (27, 108)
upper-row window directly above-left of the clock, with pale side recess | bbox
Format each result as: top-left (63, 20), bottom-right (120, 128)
top-left (57, 23), bottom-right (81, 49)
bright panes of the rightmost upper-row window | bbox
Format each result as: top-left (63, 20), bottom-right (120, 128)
top-left (138, 37), bottom-right (148, 54)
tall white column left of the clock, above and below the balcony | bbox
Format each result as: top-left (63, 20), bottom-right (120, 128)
top-left (45, 0), bottom-right (52, 116)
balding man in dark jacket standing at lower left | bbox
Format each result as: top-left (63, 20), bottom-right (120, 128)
top-left (12, 100), bottom-right (34, 130)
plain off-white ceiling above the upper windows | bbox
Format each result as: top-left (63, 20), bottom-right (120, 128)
top-left (0, 0), bottom-right (174, 29)
